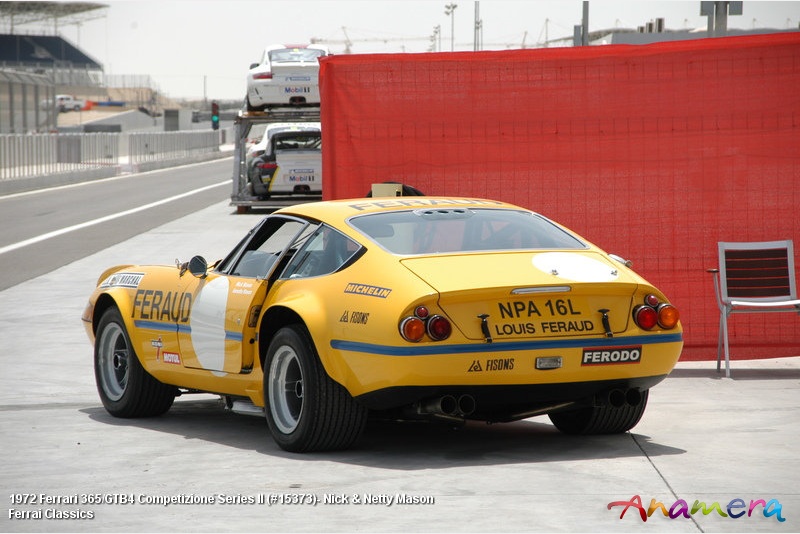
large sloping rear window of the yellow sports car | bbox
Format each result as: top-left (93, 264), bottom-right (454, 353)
top-left (349, 208), bottom-right (587, 254)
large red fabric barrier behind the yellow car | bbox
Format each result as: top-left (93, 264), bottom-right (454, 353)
top-left (320, 33), bottom-right (800, 360)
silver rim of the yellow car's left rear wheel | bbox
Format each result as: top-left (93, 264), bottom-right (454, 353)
top-left (269, 345), bottom-right (304, 434)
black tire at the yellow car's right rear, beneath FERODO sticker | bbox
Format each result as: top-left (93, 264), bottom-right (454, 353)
top-left (548, 390), bottom-right (649, 435)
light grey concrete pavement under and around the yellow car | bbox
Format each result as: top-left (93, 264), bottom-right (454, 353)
top-left (0, 202), bottom-right (800, 532)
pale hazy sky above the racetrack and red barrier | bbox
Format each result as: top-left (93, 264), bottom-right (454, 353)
top-left (7, 0), bottom-right (800, 99)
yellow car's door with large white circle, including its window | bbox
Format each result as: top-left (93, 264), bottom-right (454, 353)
top-left (178, 216), bottom-right (309, 374)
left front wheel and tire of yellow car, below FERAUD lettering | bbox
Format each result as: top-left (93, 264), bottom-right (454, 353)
top-left (94, 308), bottom-right (178, 418)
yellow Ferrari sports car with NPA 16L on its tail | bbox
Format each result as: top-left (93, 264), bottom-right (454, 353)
top-left (82, 197), bottom-right (683, 452)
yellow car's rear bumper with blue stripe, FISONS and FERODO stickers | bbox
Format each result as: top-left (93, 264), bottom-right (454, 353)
top-left (320, 332), bottom-right (683, 405)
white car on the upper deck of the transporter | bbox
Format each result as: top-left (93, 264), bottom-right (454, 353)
top-left (246, 45), bottom-right (330, 111)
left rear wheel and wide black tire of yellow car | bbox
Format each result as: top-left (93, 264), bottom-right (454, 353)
top-left (264, 325), bottom-right (367, 452)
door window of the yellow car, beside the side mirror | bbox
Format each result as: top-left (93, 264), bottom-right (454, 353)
top-left (230, 217), bottom-right (307, 278)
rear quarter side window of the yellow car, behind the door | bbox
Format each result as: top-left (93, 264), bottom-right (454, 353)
top-left (281, 225), bottom-right (360, 278)
